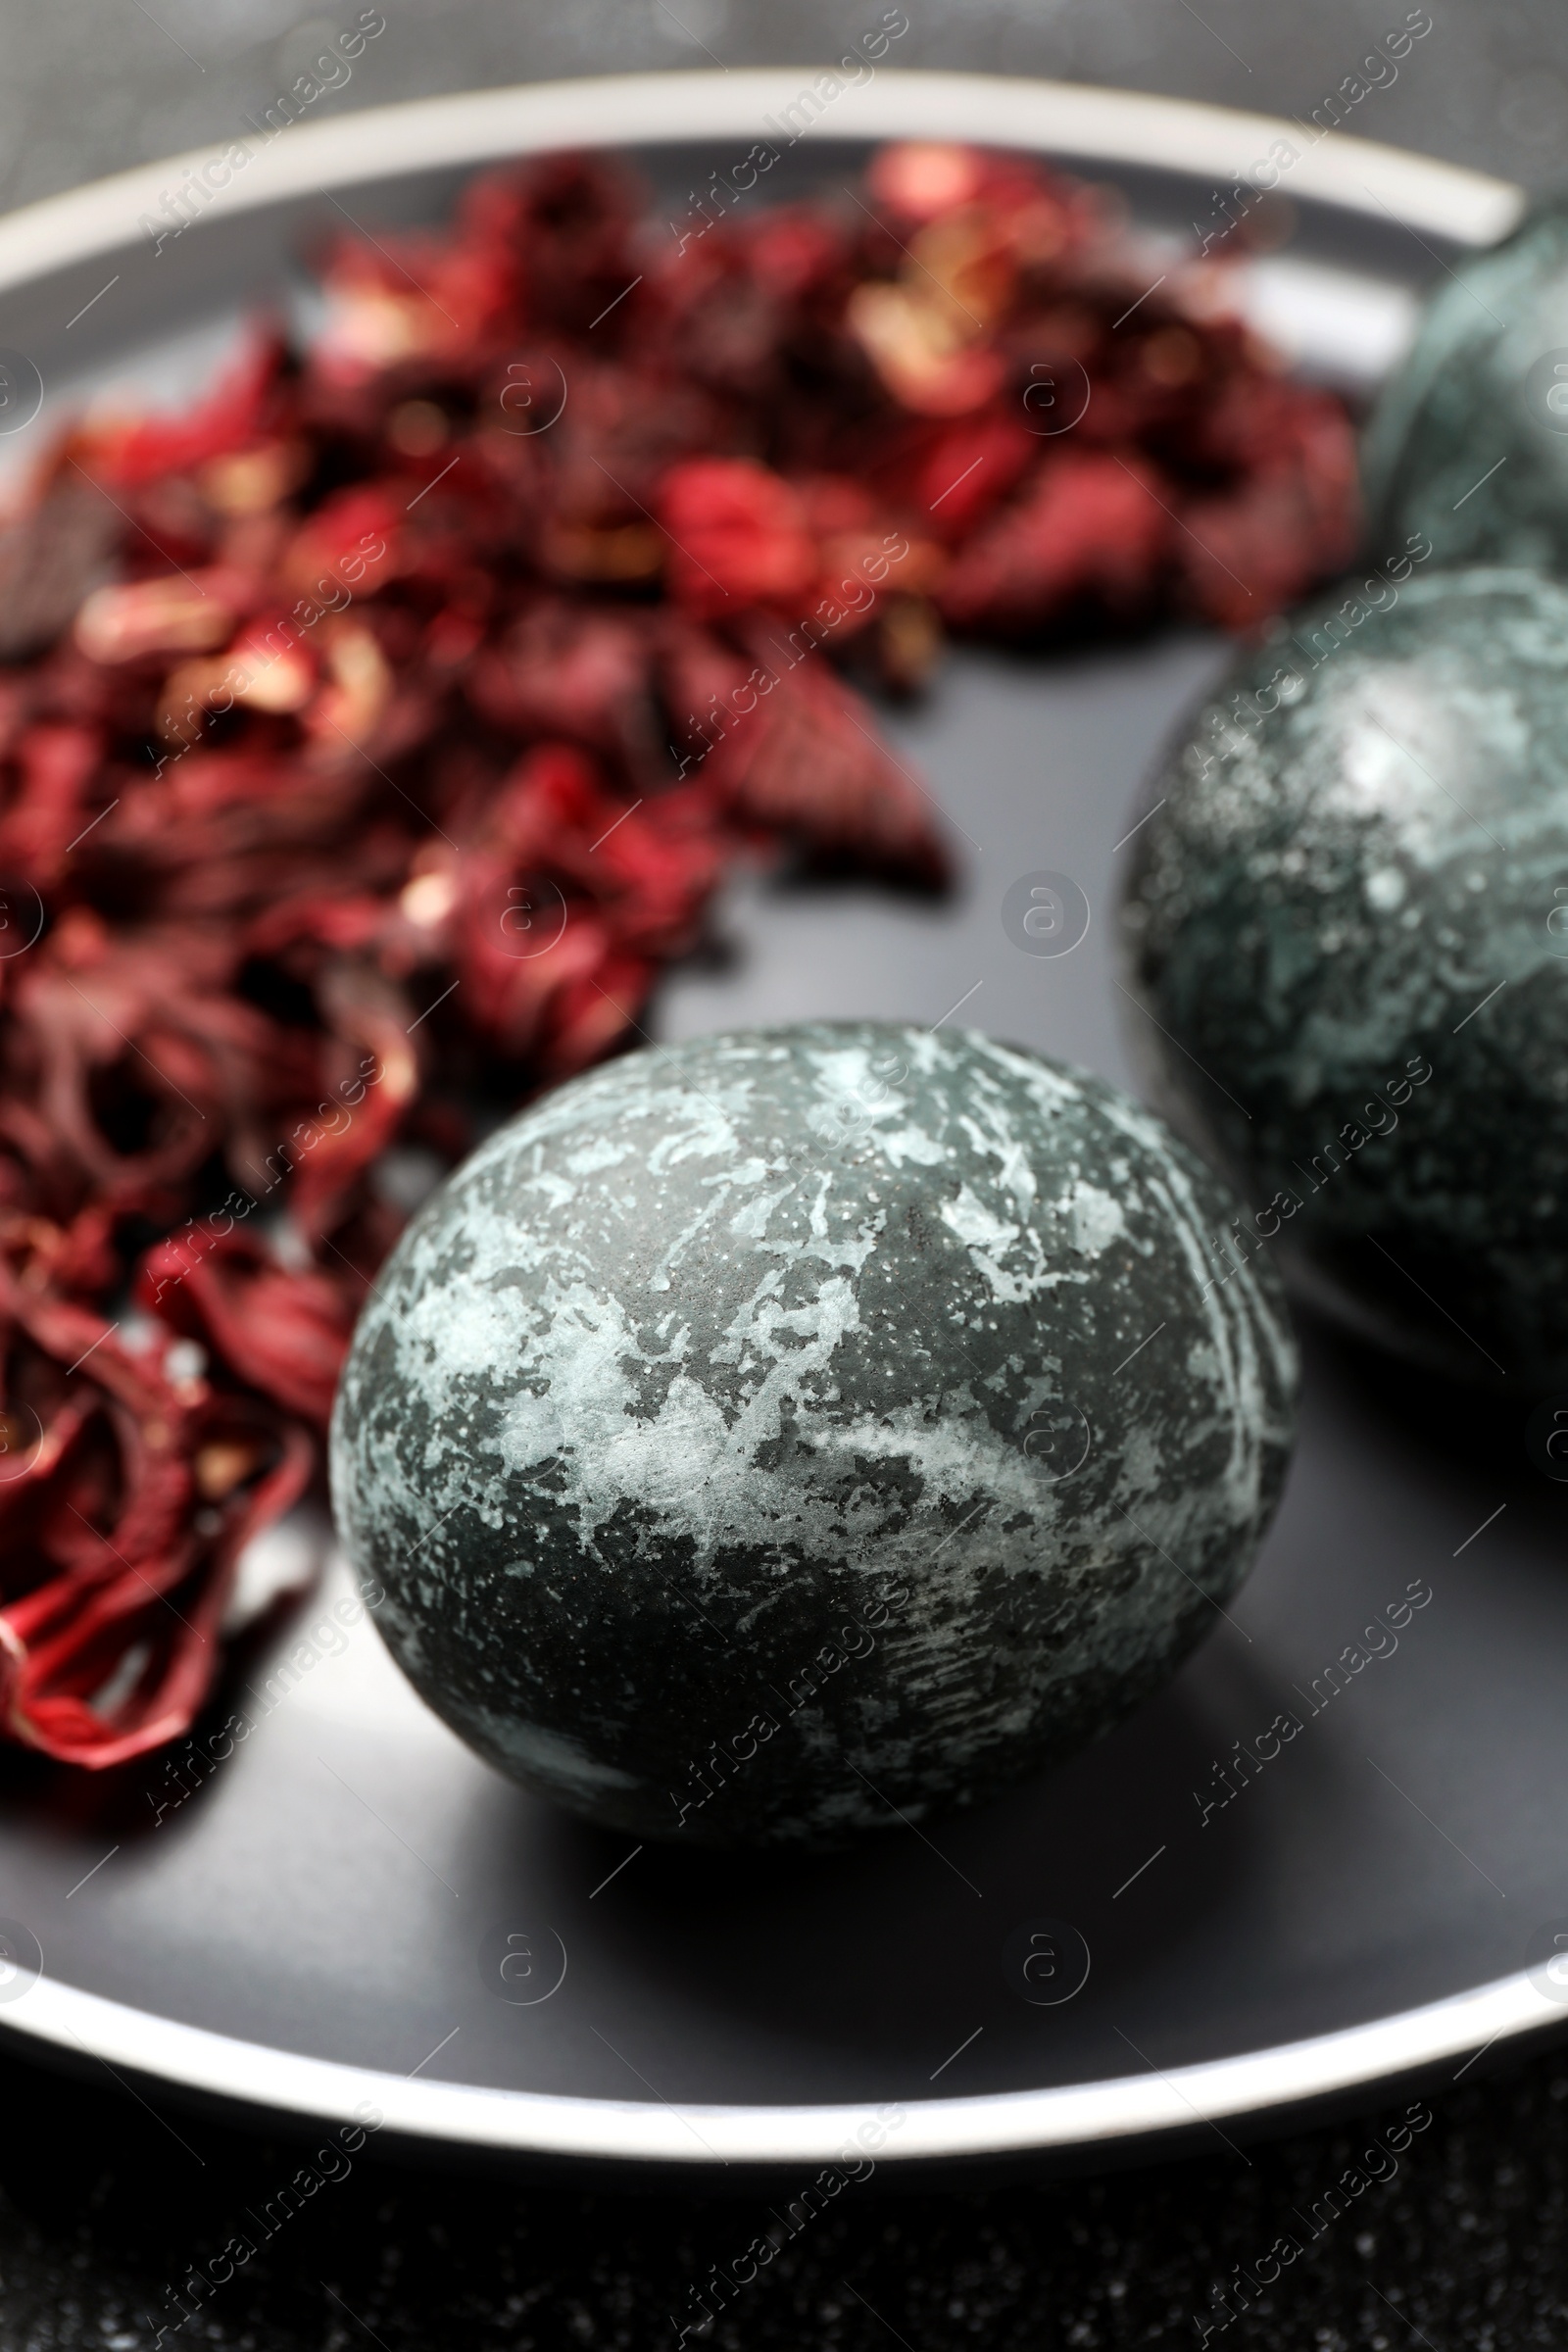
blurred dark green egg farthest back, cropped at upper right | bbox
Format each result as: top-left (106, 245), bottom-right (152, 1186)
top-left (1361, 202), bottom-right (1568, 571)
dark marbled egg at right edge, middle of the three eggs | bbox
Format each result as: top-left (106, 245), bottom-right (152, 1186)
top-left (1124, 571), bottom-right (1568, 1393)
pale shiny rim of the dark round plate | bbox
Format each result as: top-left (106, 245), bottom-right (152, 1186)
top-left (0, 66), bottom-right (1554, 2169)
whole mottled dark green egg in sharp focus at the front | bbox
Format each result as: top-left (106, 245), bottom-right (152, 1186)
top-left (331, 1023), bottom-right (1296, 1844)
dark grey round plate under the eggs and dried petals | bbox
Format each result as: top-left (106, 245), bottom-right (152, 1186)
top-left (0, 75), bottom-right (1568, 2169)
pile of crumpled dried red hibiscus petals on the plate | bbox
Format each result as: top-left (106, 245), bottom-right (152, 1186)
top-left (0, 148), bottom-right (1351, 1766)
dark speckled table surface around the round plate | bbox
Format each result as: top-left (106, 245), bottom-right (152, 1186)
top-left (0, 0), bottom-right (1568, 2352)
